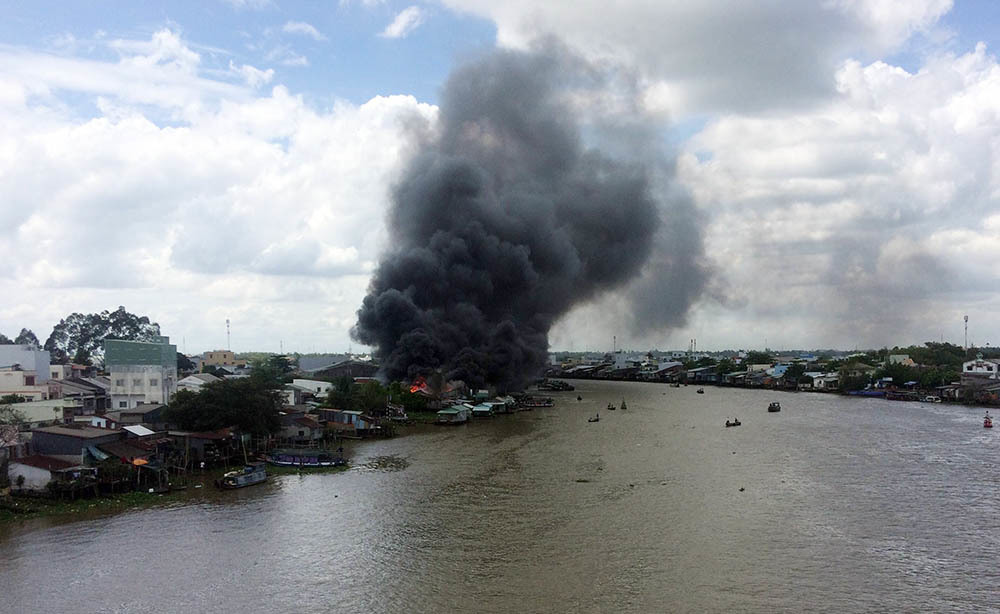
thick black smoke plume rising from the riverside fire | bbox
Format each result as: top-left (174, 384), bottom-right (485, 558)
top-left (352, 46), bottom-right (700, 390)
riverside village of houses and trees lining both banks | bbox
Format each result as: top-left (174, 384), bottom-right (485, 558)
top-left (0, 320), bottom-right (1000, 521)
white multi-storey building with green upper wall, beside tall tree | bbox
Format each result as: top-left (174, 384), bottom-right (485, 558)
top-left (104, 337), bottom-right (177, 410)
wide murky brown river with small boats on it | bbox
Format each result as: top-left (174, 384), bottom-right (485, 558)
top-left (0, 381), bottom-right (1000, 614)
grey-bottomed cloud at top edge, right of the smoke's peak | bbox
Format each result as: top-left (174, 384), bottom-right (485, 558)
top-left (442, 0), bottom-right (951, 117)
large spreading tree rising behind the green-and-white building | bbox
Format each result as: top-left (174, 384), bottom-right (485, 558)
top-left (45, 307), bottom-right (160, 364)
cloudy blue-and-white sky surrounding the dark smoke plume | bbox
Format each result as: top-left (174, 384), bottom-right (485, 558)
top-left (0, 0), bottom-right (1000, 353)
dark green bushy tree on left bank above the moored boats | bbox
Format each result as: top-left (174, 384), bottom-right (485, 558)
top-left (163, 377), bottom-right (281, 435)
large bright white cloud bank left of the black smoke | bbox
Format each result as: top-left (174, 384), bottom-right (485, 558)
top-left (0, 28), bottom-right (435, 351)
